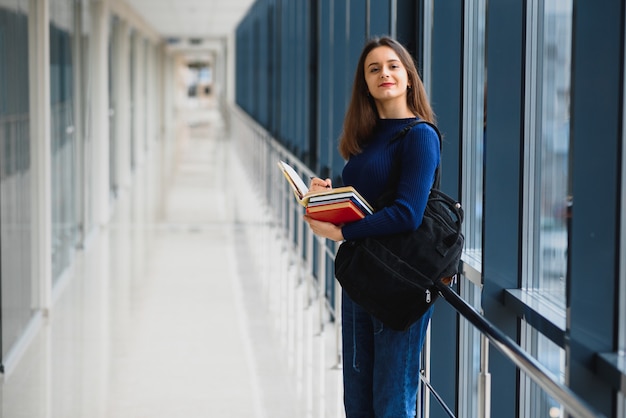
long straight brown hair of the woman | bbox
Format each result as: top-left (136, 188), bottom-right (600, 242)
top-left (339, 37), bottom-right (435, 159)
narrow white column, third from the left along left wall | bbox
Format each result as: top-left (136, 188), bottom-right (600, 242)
top-left (112, 21), bottom-right (132, 189)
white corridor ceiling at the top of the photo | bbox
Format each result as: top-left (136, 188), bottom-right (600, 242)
top-left (126, 0), bottom-right (254, 41)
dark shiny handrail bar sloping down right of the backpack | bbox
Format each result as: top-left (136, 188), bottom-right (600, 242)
top-left (437, 283), bottom-right (604, 418)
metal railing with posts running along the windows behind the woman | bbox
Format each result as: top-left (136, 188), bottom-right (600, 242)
top-left (225, 106), bottom-right (603, 418)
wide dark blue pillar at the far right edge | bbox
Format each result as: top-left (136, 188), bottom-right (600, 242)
top-left (567, 0), bottom-right (625, 416)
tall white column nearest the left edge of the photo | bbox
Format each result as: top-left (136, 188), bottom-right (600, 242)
top-left (28, 0), bottom-right (52, 311)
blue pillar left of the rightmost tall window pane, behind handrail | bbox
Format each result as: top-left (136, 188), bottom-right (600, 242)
top-left (482, 0), bottom-right (525, 416)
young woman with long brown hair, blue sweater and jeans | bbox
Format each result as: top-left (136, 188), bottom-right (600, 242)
top-left (305, 37), bottom-right (440, 418)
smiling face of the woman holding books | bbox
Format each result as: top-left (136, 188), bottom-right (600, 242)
top-left (364, 46), bottom-right (408, 103)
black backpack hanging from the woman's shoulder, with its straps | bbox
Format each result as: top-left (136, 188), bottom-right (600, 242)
top-left (335, 120), bottom-right (465, 331)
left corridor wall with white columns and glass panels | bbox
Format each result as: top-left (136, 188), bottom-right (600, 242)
top-left (0, 0), bottom-right (175, 375)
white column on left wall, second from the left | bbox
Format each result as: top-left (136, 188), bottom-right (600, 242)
top-left (91, 0), bottom-right (110, 225)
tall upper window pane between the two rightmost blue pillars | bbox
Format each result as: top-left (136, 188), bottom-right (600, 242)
top-left (536, 0), bottom-right (572, 301)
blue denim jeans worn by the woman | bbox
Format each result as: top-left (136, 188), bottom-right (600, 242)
top-left (341, 292), bottom-right (433, 418)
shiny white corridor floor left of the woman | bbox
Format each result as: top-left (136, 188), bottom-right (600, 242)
top-left (0, 103), bottom-right (342, 418)
